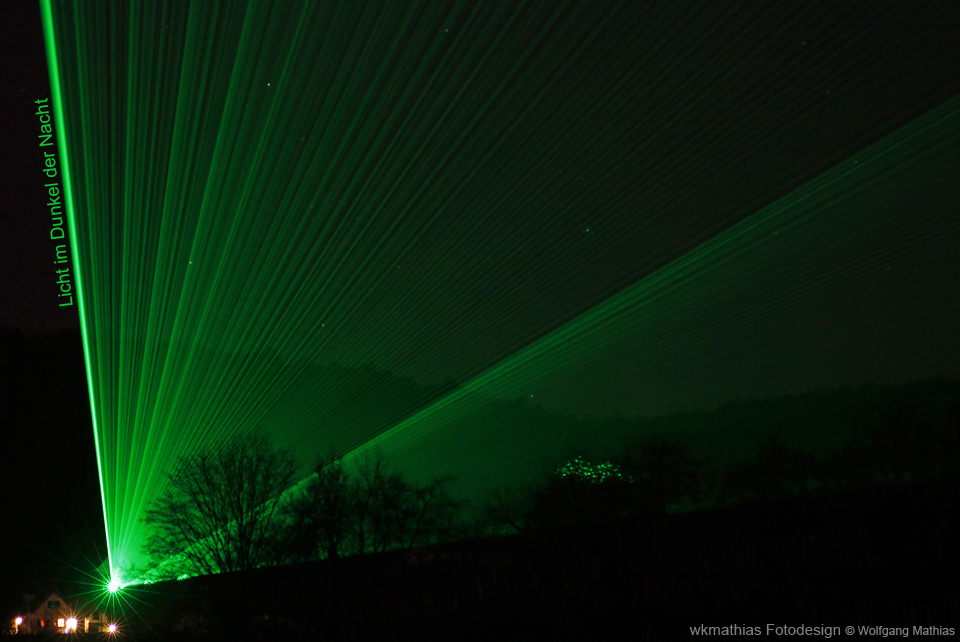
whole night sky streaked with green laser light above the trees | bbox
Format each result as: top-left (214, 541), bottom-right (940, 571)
top-left (0, 2), bottom-right (960, 592)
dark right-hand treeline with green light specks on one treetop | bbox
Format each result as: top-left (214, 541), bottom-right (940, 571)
top-left (482, 379), bottom-right (960, 533)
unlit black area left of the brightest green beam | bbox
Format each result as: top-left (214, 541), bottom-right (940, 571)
top-left (0, 2), bottom-right (94, 596)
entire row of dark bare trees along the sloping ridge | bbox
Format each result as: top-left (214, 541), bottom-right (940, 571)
top-left (137, 372), bottom-right (960, 588)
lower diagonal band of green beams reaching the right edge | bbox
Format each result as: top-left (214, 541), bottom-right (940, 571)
top-left (146, 97), bottom-right (960, 576)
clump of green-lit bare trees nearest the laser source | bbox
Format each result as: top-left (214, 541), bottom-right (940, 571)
top-left (141, 440), bottom-right (469, 581)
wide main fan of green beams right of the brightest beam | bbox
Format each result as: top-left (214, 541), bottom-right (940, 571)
top-left (42, 0), bottom-right (955, 569)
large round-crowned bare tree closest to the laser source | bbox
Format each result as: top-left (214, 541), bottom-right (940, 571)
top-left (143, 432), bottom-right (297, 576)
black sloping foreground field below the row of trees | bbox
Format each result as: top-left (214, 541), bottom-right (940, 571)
top-left (26, 483), bottom-right (960, 640)
